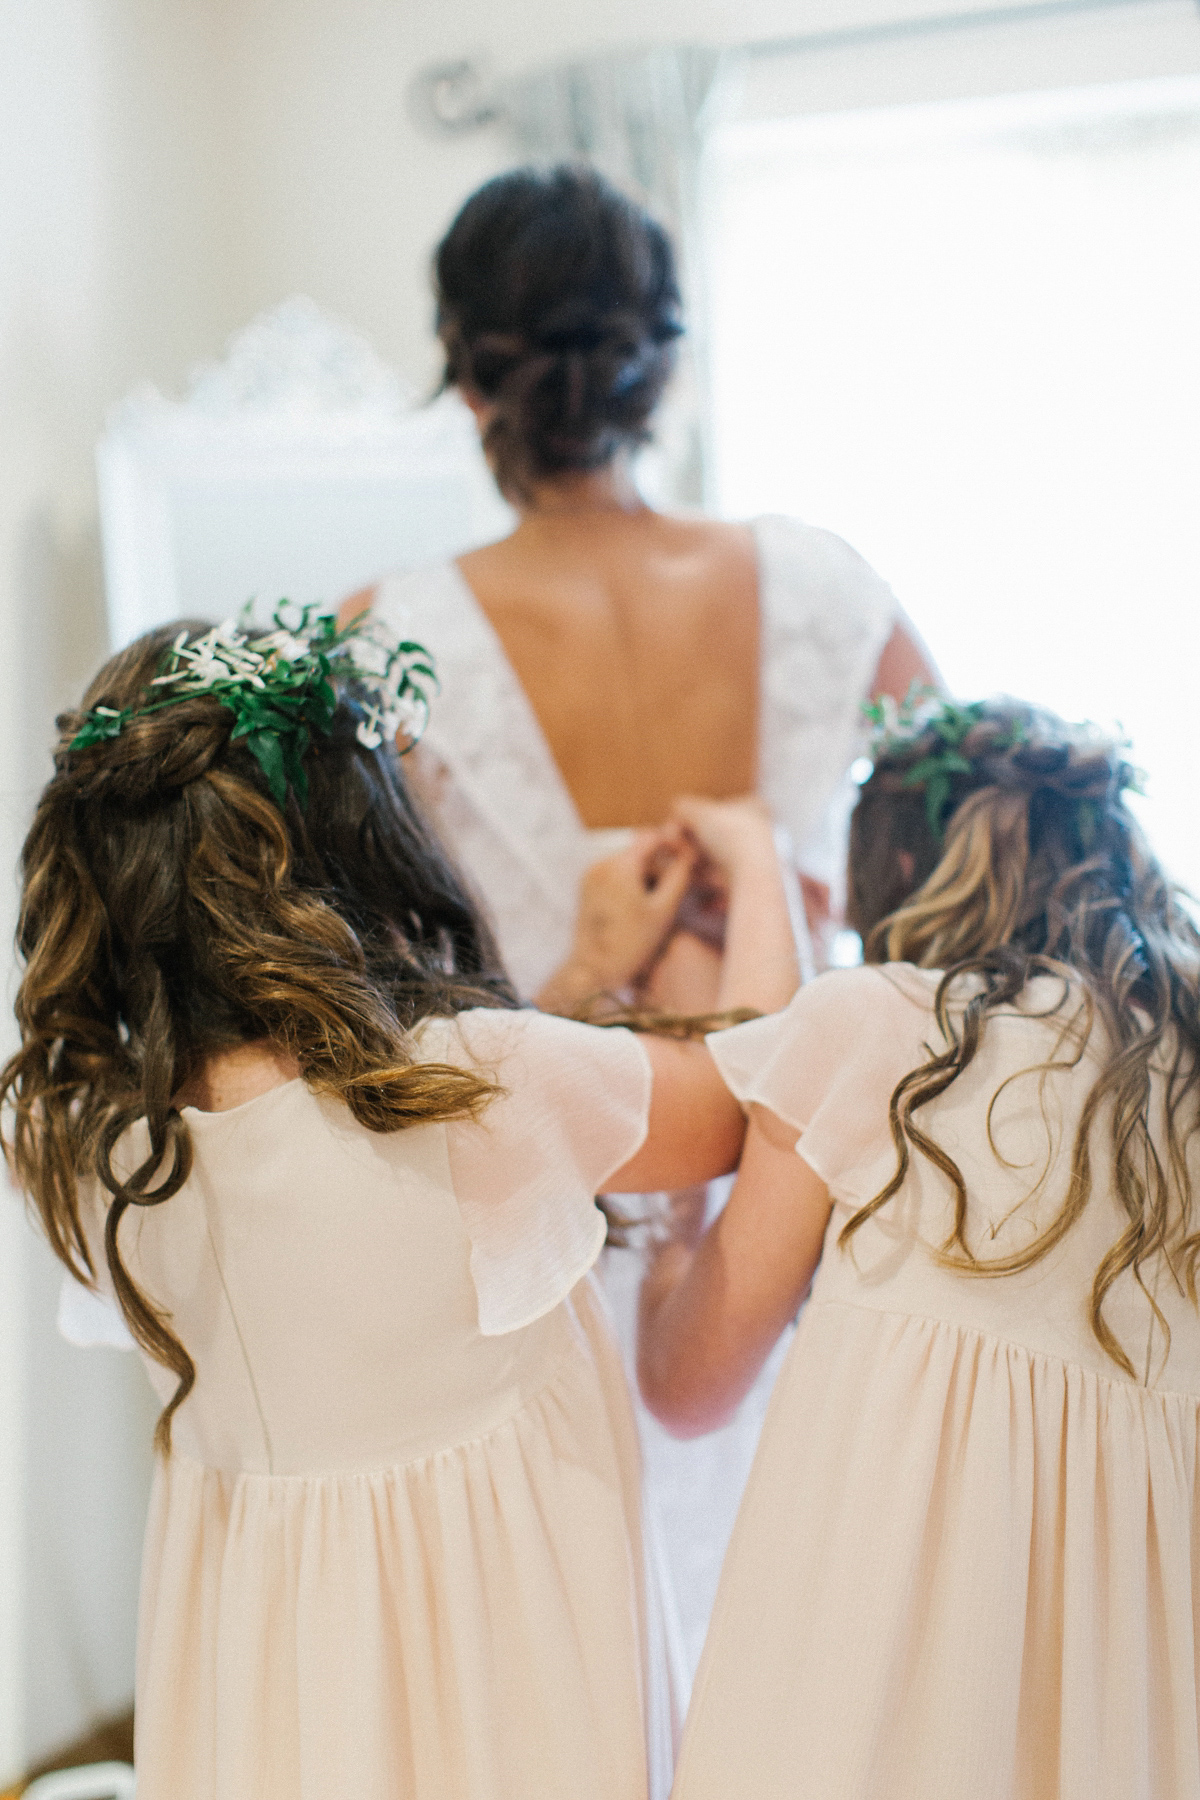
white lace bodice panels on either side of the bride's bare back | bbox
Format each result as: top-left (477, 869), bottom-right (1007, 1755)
top-left (376, 517), bottom-right (896, 994)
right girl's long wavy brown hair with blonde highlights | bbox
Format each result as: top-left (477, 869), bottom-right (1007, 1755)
top-left (840, 700), bottom-right (1200, 1377)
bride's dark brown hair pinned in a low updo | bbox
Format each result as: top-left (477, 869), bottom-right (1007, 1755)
top-left (434, 166), bottom-right (684, 495)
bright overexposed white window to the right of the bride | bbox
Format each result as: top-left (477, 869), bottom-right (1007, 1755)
top-left (703, 9), bottom-right (1200, 889)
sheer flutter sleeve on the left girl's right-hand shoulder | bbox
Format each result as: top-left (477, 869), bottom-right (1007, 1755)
top-left (431, 1010), bottom-right (651, 1337)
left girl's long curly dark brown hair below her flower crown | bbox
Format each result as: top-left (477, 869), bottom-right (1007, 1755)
top-left (0, 621), bottom-right (516, 1451)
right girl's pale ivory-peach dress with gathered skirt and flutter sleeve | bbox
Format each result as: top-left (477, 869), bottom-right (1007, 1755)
top-left (673, 965), bottom-right (1200, 1800)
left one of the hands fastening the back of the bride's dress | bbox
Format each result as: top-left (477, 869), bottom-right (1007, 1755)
top-left (538, 826), bottom-right (696, 1012)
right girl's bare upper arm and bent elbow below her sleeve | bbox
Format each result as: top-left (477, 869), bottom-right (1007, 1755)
top-left (637, 1107), bottom-right (831, 1438)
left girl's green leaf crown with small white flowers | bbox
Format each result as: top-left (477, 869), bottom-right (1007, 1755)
top-left (68, 599), bottom-right (437, 806)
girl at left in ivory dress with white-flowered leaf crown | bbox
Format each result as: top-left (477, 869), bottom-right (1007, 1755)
top-left (2, 616), bottom-right (795, 1800)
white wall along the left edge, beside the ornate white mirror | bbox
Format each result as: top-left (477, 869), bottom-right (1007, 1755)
top-left (0, 0), bottom-right (237, 1786)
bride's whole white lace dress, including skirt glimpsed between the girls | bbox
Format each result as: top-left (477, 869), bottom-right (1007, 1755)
top-left (376, 517), bottom-right (896, 1669)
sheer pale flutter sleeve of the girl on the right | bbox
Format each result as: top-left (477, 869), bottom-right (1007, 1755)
top-left (707, 968), bottom-right (932, 1195)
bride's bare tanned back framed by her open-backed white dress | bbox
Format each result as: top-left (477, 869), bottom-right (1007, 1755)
top-left (459, 511), bottom-right (759, 828)
